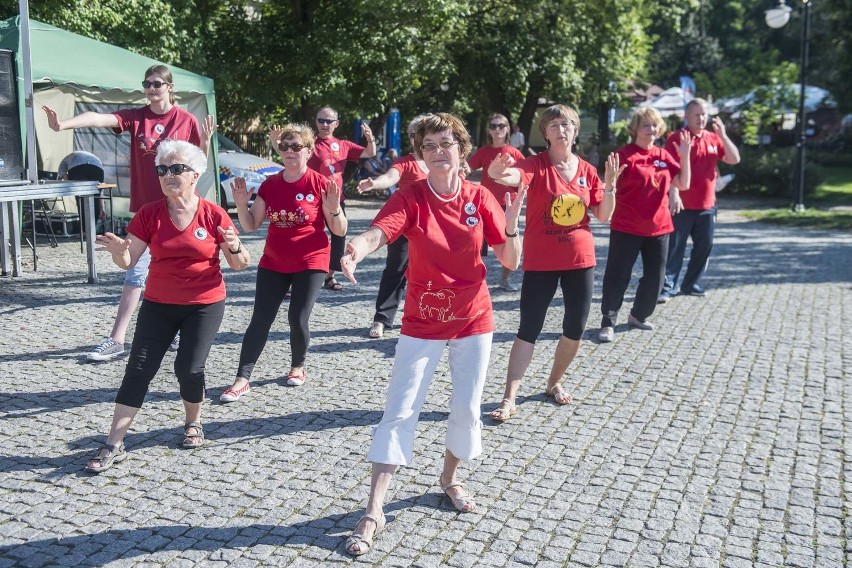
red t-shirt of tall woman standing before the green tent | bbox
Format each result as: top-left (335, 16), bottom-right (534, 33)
top-left (112, 106), bottom-right (201, 212)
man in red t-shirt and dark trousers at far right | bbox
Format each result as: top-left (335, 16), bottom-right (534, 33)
top-left (658, 99), bottom-right (740, 304)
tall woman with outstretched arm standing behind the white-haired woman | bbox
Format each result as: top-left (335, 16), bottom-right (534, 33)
top-left (42, 65), bottom-right (216, 361)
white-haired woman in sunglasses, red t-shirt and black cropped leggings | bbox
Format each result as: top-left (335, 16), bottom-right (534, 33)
top-left (86, 140), bottom-right (250, 473)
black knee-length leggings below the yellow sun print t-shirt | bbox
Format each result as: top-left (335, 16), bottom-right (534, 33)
top-left (518, 267), bottom-right (595, 343)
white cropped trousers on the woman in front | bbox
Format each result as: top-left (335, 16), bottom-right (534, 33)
top-left (367, 332), bottom-right (494, 466)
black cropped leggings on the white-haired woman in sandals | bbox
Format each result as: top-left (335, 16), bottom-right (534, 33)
top-left (115, 300), bottom-right (225, 408)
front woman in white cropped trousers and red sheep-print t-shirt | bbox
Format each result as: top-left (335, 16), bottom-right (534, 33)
top-left (341, 113), bottom-right (525, 556)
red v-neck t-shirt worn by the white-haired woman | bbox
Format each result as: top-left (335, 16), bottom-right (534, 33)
top-left (127, 198), bottom-right (237, 305)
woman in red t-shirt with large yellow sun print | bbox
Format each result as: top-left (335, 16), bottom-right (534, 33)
top-left (488, 105), bottom-right (623, 420)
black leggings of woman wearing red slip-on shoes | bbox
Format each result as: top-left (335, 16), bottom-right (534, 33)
top-left (237, 268), bottom-right (325, 379)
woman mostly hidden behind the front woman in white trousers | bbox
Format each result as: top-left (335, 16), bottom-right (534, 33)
top-left (358, 114), bottom-right (431, 339)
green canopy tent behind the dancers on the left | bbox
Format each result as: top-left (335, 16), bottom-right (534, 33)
top-left (0, 16), bottom-right (219, 209)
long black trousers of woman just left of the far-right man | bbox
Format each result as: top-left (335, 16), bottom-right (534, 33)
top-left (601, 230), bottom-right (669, 327)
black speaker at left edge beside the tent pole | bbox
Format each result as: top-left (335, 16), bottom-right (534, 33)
top-left (0, 49), bottom-right (22, 181)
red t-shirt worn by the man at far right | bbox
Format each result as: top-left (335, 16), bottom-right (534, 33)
top-left (666, 129), bottom-right (725, 211)
